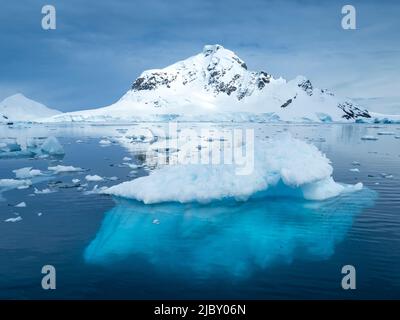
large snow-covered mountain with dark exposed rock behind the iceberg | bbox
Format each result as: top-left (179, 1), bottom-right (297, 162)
top-left (46, 45), bottom-right (390, 122)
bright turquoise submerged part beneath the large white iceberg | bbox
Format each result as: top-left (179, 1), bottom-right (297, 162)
top-left (84, 189), bottom-right (375, 277)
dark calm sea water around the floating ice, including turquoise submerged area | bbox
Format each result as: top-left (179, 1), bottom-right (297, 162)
top-left (0, 124), bottom-right (400, 299)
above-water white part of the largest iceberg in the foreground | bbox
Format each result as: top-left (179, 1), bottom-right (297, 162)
top-left (104, 136), bottom-right (362, 203)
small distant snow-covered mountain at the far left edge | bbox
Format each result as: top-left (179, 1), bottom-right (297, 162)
top-left (0, 93), bottom-right (61, 122)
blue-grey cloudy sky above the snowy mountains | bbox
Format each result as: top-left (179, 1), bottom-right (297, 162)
top-left (0, 0), bottom-right (400, 113)
